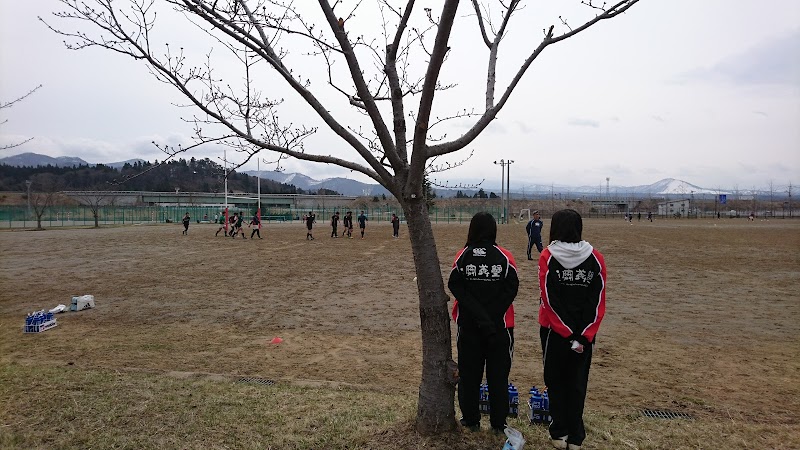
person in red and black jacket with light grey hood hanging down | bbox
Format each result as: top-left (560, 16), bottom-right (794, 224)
top-left (539, 209), bottom-right (606, 449)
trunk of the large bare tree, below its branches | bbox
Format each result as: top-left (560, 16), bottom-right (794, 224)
top-left (402, 198), bottom-right (458, 435)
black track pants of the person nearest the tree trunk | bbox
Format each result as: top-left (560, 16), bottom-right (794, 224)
top-left (457, 326), bottom-right (514, 430)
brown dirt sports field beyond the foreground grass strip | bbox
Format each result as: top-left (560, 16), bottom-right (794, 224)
top-left (0, 219), bottom-right (800, 448)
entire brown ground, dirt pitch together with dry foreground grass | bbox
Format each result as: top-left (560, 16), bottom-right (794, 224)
top-left (0, 219), bottom-right (800, 449)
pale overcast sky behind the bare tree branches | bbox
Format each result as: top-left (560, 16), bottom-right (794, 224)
top-left (0, 0), bottom-right (800, 189)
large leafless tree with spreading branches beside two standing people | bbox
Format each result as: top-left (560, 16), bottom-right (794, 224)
top-left (48, 0), bottom-right (638, 434)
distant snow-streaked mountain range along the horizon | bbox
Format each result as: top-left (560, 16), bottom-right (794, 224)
top-left (0, 153), bottom-right (766, 197)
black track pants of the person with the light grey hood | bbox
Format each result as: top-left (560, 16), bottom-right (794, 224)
top-left (539, 327), bottom-right (593, 445)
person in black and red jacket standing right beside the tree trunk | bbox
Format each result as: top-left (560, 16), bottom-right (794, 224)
top-left (447, 212), bottom-right (519, 433)
